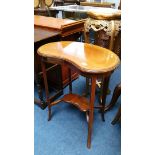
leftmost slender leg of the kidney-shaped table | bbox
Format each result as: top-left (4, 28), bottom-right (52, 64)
top-left (41, 60), bottom-right (51, 121)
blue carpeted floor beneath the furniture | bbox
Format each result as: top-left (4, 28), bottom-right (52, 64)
top-left (34, 67), bottom-right (121, 155)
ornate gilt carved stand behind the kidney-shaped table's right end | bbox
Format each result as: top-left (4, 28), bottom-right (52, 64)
top-left (85, 8), bottom-right (121, 100)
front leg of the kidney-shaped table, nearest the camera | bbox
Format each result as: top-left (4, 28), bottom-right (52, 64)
top-left (87, 77), bottom-right (96, 148)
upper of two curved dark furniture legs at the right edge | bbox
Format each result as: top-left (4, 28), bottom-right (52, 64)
top-left (105, 84), bottom-right (121, 111)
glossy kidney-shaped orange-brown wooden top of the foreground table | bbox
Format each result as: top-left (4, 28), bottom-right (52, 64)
top-left (38, 41), bottom-right (120, 74)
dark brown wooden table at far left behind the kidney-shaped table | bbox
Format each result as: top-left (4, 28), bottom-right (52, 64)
top-left (34, 26), bottom-right (63, 109)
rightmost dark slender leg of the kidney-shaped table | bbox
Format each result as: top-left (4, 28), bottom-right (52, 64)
top-left (101, 75), bottom-right (110, 121)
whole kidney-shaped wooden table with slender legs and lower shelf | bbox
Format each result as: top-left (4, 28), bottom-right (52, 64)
top-left (37, 41), bottom-right (120, 148)
